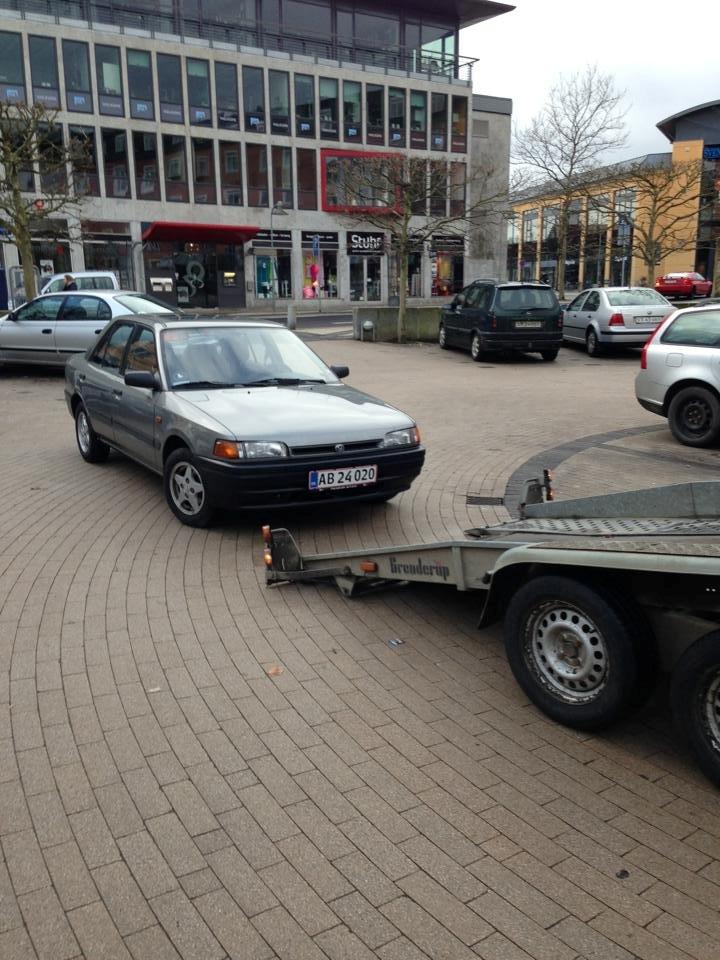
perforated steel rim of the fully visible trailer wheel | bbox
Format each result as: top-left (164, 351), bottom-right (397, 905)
top-left (523, 600), bottom-right (610, 704)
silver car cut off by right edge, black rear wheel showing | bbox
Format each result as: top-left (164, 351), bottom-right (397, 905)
top-left (635, 305), bottom-right (720, 447)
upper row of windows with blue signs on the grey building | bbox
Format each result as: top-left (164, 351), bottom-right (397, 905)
top-left (0, 31), bottom-right (468, 153)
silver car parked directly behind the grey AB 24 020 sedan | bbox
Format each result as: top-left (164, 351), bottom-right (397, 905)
top-left (0, 290), bottom-right (173, 367)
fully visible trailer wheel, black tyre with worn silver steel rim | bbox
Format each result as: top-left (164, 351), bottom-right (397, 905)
top-left (505, 576), bottom-right (650, 730)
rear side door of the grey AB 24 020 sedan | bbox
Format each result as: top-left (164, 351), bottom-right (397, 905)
top-left (77, 321), bottom-right (135, 443)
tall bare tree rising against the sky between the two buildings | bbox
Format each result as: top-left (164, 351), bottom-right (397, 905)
top-left (513, 66), bottom-right (627, 297)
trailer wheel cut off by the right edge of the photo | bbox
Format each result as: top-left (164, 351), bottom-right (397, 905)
top-left (670, 630), bottom-right (720, 786)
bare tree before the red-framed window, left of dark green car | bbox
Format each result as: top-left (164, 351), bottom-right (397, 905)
top-left (328, 154), bottom-right (508, 343)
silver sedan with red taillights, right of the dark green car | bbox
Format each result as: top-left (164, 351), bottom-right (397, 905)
top-left (563, 287), bottom-right (673, 357)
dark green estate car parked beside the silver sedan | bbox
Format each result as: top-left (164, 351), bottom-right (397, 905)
top-left (438, 280), bottom-right (562, 360)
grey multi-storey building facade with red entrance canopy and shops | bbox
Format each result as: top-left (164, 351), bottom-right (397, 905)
top-left (0, 0), bottom-right (512, 308)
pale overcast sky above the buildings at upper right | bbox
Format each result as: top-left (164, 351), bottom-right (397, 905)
top-left (460, 0), bottom-right (720, 159)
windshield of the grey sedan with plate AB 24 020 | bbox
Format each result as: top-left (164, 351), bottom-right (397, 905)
top-left (160, 326), bottom-right (338, 390)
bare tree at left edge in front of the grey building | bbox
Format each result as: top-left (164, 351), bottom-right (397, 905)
top-left (0, 103), bottom-right (89, 300)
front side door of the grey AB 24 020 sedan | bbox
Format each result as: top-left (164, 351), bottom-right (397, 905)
top-left (113, 324), bottom-right (160, 469)
